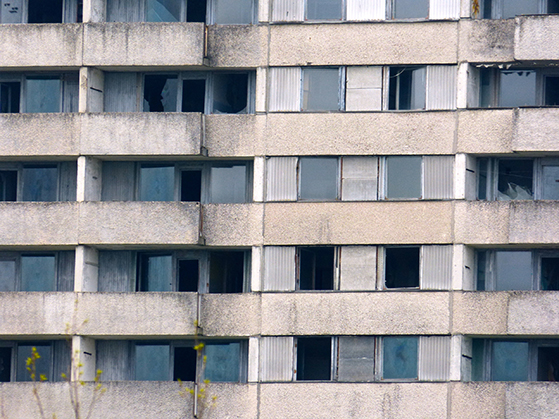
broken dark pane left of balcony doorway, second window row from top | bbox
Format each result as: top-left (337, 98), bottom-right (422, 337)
top-left (144, 75), bottom-right (178, 112)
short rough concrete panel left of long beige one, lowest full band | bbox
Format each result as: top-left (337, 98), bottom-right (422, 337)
top-left (199, 293), bottom-right (261, 336)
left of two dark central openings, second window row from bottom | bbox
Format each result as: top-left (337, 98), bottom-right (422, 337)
top-left (299, 247), bottom-right (334, 290)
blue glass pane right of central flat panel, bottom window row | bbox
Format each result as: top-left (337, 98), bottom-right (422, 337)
top-left (382, 337), bottom-right (418, 379)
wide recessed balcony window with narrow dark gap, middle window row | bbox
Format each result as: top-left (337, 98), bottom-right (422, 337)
top-left (101, 161), bottom-right (252, 204)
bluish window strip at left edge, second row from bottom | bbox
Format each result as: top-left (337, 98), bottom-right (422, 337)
top-left (0, 251), bottom-right (74, 291)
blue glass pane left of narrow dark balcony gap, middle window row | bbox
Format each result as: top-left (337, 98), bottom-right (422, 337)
top-left (140, 166), bottom-right (175, 201)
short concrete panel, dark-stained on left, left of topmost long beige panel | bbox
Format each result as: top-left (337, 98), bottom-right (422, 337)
top-left (208, 25), bottom-right (268, 68)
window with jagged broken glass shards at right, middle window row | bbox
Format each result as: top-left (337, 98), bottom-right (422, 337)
top-left (497, 159), bottom-right (534, 201)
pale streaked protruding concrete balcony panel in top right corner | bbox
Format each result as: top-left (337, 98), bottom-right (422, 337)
top-left (514, 15), bottom-right (559, 61)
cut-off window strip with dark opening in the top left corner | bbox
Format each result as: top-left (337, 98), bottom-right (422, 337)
top-left (0, 0), bottom-right (83, 23)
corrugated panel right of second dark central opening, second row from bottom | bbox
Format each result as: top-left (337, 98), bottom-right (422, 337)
top-left (420, 246), bottom-right (453, 290)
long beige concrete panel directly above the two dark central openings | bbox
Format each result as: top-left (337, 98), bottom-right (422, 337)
top-left (264, 201), bottom-right (453, 245)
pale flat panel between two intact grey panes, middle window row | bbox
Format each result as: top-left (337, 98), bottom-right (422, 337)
top-left (342, 157), bottom-right (378, 201)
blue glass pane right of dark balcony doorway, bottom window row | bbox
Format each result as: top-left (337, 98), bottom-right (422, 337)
top-left (204, 342), bottom-right (241, 381)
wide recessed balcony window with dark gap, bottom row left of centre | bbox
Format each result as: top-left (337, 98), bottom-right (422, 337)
top-left (97, 340), bottom-right (248, 382)
